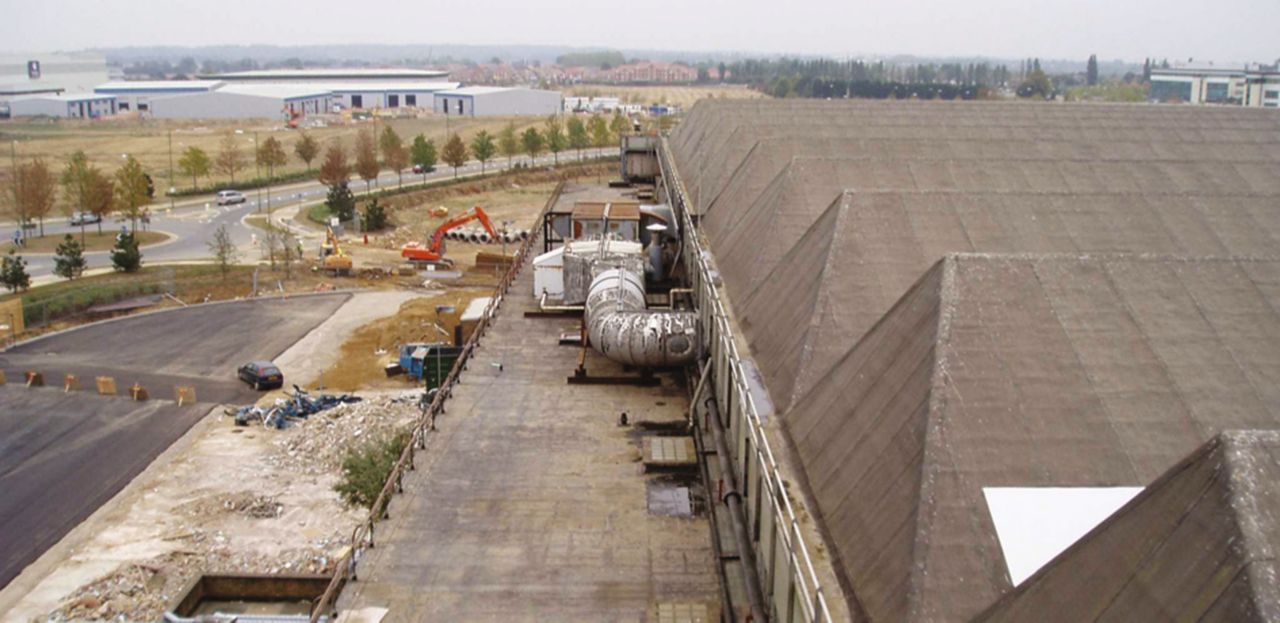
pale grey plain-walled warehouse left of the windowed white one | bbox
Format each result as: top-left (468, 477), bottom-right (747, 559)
top-left (150, 84), bottom-right (332, 119)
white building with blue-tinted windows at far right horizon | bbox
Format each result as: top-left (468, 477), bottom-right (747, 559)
top-left (1149, 65), bottom-right (1280, 109)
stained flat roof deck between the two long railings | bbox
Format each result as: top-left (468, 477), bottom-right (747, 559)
top-left (339, 237), bottom-right (719, 623)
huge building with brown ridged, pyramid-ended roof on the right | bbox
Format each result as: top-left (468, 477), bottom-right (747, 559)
top-left (662, 100), bottom-right (1280, 622)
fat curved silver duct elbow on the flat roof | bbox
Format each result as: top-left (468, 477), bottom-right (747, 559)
top-left (585, 267), bottom-right (698, 367)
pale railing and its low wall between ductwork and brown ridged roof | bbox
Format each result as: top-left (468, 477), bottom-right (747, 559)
top-left (658, 137), bottom-right (832, 622)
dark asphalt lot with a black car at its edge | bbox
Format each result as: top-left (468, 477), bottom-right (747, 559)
top-left (0, 294), bottom-right (349, 588)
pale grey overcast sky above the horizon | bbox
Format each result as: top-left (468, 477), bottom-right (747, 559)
top-left (0, 0), bottom-right (1280, 63)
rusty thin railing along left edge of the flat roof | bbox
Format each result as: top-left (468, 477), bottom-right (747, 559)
top-left (311, 182), bottom-right (564, 623)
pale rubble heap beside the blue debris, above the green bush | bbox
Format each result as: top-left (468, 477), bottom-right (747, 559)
top-left (266, 391), bottom-right (421, 475)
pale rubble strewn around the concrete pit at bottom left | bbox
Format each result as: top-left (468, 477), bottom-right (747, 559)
top-left (46, 530), bottom-right (347, 623)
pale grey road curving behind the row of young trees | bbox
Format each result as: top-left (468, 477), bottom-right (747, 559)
top-left (8, 148), bottom-right (618, 283)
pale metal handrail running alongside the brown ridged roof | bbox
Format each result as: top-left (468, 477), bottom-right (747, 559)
top-left (658, 136), bottom-right (832, 622)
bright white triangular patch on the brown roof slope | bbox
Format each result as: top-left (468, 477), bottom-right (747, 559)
top-left (982, 486), bottom-right (1142, 586)
